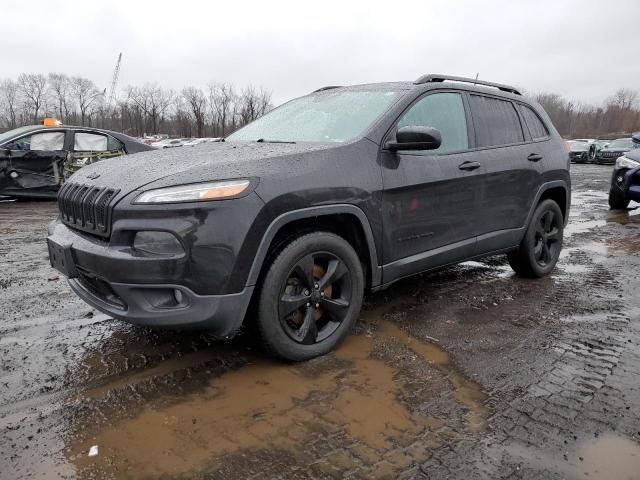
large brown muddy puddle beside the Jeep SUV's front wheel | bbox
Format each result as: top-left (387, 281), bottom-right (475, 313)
top-left (69, 320), bottom-right (488, 477)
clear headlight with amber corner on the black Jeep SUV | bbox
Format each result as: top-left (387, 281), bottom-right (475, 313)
top-left (133, 180), bottom-right (250, 203)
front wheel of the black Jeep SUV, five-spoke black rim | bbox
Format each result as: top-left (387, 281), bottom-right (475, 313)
top-left (256, 232), bottom-right (364, 362)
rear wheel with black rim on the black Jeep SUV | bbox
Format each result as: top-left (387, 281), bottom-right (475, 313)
top-left (507, 200), bottom-right (564, 278)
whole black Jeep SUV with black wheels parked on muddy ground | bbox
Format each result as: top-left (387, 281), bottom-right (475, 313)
top-left (48, 75), bottom-right (570, 360)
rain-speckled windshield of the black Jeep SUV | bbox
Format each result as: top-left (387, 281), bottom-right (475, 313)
top-left (225, 90), bottom-right (398, 142)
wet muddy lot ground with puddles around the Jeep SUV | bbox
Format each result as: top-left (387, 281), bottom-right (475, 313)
top-left (0, 165), bottom-right (640, 480)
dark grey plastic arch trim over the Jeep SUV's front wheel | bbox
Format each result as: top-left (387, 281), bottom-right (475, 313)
top-left (247, 204), bottom-right (382, 288)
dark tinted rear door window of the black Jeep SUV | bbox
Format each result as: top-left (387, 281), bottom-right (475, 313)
top-left (469, 95), bottom-right (524, 147)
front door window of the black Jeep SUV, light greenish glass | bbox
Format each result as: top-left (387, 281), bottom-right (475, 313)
top-left (397, 92), bottom-right (469, 154)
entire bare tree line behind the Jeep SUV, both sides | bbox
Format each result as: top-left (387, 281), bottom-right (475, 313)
top-left (0, 73), bottom-right (640, 138)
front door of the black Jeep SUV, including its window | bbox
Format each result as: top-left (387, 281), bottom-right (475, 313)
top-left (381, 92), bottom-right (483, 283)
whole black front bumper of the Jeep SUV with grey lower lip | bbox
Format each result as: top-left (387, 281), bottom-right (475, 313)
top-left (47, 189), bottom-right (262, 337)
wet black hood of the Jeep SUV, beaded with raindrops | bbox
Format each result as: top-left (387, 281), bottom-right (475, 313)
top-left (69, 142), bottom-right (342, 194)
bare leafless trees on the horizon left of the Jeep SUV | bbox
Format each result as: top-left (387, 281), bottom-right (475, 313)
top-left (0, 73), bottom-right (272, 137)
